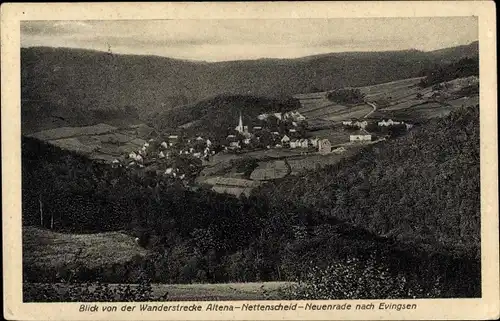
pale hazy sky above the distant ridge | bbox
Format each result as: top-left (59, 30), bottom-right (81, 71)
top-left (21, 17), bottom-right (478, 61)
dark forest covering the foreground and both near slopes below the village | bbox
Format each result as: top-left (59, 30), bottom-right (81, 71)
top-left (22, 107), bottom-right (481, 298)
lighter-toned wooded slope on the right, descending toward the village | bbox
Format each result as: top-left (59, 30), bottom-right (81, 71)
top-left (254, 106), bottom-right (480, 258)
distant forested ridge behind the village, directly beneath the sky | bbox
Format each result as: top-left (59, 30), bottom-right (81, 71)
top-left (21, 42), bottom-right (478, 131)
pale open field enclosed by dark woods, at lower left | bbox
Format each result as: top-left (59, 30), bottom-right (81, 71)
top-left (23, 226), bottom-right (147, 268)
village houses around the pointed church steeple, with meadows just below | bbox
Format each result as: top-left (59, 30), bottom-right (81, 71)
top-left (112, 102), bottom-right (413, 196)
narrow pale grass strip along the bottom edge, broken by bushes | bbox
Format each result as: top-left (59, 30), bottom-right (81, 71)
top-left (23, 282), bottom-right (293, 301)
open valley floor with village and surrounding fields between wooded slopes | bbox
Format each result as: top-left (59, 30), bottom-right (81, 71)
top-left (25, 70), bottom-right (479, 197)
